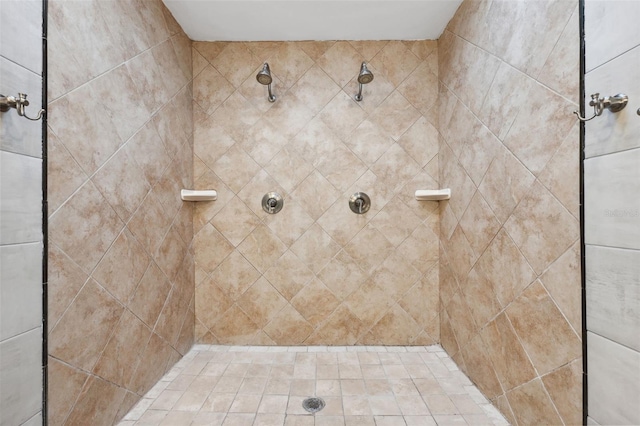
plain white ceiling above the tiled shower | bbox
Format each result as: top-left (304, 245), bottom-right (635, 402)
top-left (163, 0), bottom-right (462, 41)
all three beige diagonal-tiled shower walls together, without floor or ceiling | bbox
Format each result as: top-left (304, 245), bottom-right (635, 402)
top-left (49, 0), bottom-right (582, 424)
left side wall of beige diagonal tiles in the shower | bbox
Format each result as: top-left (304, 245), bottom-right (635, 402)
top-left (48, 0), bottom-right (194, 425)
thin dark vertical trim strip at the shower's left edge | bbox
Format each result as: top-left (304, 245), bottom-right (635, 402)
top-left (42, 0), bottom-right (49, 426)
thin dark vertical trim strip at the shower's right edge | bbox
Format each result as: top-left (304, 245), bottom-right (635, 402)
top-left (578, 0), bottom-right (589, 425)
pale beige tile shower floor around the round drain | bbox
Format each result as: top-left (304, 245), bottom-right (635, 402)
top-left (119, 345), bottom-right (508, 426)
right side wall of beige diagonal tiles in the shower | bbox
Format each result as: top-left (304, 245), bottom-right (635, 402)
top-left (438, 0), bottom-right (582, 424)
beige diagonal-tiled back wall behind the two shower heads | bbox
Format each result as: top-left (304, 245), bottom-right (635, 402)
top-left (193, 41), bottom-right (439, 345)
